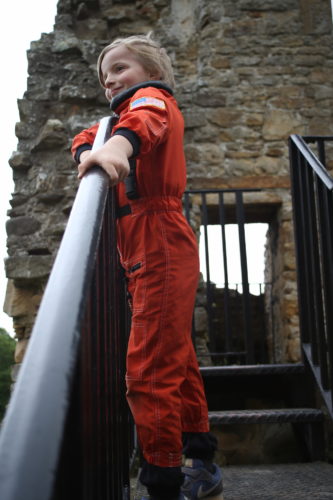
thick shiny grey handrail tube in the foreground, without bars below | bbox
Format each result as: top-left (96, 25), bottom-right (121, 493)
top-left (0, 118), bottom-right (109, 500)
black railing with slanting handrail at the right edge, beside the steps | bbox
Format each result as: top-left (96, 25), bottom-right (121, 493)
top-left (289, 135), bottom-right (333, 417)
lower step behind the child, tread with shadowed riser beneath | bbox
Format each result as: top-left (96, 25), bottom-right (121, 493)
top-left (209, 408), bottom-right (325, 464)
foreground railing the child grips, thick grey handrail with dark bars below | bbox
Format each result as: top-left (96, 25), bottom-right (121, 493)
top-left (0, 118), bottom-right (131, 500)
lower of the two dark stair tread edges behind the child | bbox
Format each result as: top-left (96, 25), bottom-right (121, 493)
top-left (209, 408), bottom-right (324, 424)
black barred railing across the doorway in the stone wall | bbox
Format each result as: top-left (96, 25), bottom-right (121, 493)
top-left (184, 189), bottom-right (271, 365)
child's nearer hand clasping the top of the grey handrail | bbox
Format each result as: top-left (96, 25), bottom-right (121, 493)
top-left (78, 135), bottom-right (133, 186)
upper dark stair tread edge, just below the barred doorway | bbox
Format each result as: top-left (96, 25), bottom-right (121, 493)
top-left (200, 363), bottom-right (304, 377)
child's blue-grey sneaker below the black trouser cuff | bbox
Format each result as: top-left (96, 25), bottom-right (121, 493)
top-left (182, 458), bottom-right (223, 500)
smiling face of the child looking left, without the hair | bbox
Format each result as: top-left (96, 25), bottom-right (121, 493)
top-left (101, 45), bottom-right (154, 100)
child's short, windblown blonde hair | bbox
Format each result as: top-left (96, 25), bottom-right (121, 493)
top-left (97, 33), bottom-right (175, 88)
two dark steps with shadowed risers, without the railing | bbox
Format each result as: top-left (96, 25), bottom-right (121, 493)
top-left (201, 364), bottom-right (325, 465)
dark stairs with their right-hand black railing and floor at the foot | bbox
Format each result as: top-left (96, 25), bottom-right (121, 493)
top-left (195, 136), bottom-right (333, 500)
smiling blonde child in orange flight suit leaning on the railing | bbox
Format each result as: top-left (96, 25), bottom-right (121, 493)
top-left (72, 36), bottom-right (222, 500)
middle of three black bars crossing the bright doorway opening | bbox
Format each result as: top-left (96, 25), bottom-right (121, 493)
top-left (219, 193), bottom-right (232, 351)
